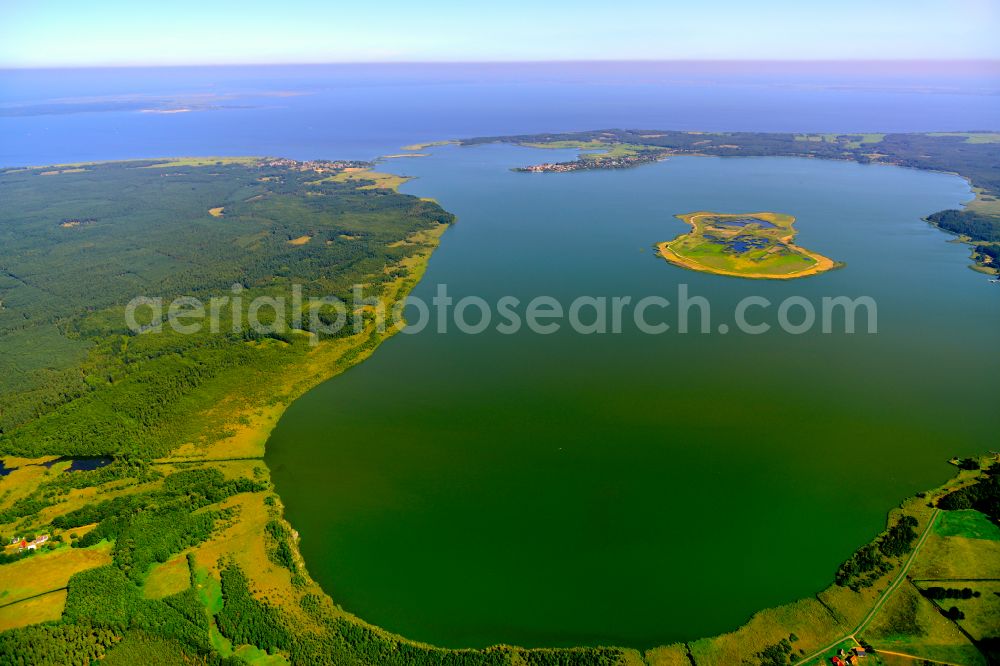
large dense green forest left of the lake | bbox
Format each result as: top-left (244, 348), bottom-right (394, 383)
top-left (0, 161), bottom-right (451, 455)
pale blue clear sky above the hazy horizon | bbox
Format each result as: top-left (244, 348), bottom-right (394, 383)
top-left (0, 0), bottom-right (1000, 68)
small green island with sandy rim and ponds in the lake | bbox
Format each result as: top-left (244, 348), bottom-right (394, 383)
top-left (657, 211), bottom-right (839, 280)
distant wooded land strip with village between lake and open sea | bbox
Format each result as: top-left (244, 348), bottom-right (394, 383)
top-left (474, 129), bottom-right (1000, 275)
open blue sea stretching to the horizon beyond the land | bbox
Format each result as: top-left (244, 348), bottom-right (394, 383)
top-left (0, 62), bottom-right (1000, 166)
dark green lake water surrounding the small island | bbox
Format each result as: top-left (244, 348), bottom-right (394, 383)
top-left (267, 146), bottom-right (1000, 648)
